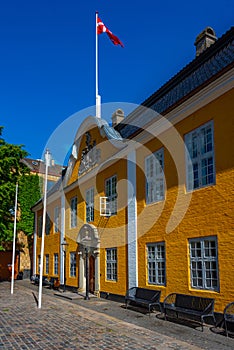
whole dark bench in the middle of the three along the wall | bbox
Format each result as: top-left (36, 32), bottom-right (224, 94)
top-left (163, 293), bottom-right (216, 331)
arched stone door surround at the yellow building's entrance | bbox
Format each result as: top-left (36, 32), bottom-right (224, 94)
top-left (76, 224), bottom-right (100, 296)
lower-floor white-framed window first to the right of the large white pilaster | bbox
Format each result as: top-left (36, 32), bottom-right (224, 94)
top-left (147, 242), bottom-right (166, 286)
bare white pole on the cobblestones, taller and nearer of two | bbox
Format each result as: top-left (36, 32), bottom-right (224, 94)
top-left (38, 149), bottom-right (51, 309)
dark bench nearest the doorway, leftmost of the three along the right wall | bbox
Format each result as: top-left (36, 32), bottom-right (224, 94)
top-left (125, 287), bottom-right (161, 314)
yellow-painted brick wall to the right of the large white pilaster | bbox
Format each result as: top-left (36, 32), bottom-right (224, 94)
top-left (137, 92), bottom-right (234, 311)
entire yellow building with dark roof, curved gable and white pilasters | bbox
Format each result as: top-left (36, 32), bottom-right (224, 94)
top-left (33, 27), bottom-right (234, 312)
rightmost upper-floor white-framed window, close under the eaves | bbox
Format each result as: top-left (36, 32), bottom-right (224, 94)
top-left (185, 121), bottom-right (215, 191)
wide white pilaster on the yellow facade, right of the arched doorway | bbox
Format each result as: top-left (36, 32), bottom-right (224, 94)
top-left (127, 150), bottom-right (138, 288)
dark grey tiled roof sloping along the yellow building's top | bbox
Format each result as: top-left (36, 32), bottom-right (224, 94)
top-left (117, 27), bottom-right (234, 138)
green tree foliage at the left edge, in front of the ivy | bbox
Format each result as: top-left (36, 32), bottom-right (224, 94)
top-left (0, 126), bottom-right (29, 250)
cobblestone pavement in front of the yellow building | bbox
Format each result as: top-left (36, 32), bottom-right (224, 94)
top-left (0, 281), bottom-right (234, 350)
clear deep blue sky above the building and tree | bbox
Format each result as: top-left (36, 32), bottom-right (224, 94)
top-left (0, 0), bottom-right (234, 162)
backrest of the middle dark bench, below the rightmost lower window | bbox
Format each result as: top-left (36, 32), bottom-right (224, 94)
top-left (175, 294), bottom-right (214, 311)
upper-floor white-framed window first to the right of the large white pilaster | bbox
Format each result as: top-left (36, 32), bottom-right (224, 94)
top-left (145, 148), bottom-right (165, 204)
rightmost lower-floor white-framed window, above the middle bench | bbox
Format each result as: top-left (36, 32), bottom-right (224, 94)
top-left (189, 237), bottom-right (218, 290)
